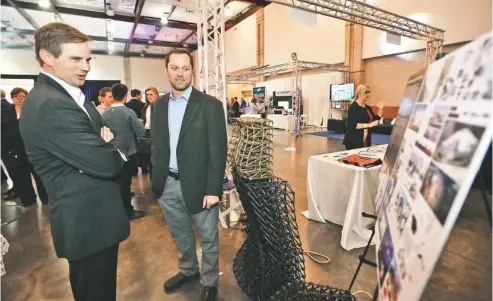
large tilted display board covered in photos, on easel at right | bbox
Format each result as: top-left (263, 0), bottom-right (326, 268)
top-left (375, 33), bottom-right (493, 301)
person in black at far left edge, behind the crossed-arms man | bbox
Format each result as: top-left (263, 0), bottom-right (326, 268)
top-left (1, 87), bottom-right (49, 207)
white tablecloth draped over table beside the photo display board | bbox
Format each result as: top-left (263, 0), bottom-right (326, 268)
top-left (307, 145), bottom-right (387, 251)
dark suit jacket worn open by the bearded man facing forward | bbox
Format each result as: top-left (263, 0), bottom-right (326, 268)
top-left (151, 89), bottom-right (227, 214)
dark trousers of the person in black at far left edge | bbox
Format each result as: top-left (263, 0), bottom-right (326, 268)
top-left (2, 153), bottom-right (48, 206)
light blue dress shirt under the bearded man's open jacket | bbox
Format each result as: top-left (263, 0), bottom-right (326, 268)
top-left (168, 86), bottom-right (192, 172)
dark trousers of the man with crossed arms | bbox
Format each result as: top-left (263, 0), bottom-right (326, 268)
top-left (69, 244), bottom-right (118, 301)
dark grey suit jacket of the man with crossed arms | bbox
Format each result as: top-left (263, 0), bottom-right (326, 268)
top-left (20, 74), bottom-right (130, 260)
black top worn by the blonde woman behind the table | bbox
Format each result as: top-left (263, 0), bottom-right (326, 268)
top-left (343, 101), bottom-right (382, 148)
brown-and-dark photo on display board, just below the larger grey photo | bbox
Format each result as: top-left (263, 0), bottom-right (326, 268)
top-left (421, 163), bottom-right (459, 225)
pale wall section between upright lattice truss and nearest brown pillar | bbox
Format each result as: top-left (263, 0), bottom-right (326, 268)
top-left (224, 14), bottom-right (257, 72)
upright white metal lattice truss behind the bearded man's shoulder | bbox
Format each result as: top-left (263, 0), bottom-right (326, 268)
top-left (197, 0), bottom-right (227, 118)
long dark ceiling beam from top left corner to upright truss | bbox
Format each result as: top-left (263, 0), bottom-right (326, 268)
top-left (1, 0), bottom-right (197, 30)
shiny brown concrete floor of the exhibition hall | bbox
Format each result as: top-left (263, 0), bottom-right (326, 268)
top-left (1, 130), bottom-right (492, 301)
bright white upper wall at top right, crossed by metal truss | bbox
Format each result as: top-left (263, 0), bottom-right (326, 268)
top-left (363, 0), bottom-right (492, 58)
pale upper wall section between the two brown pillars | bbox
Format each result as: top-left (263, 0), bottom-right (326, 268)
top-left (264, 1), bottom-right (344, 65)
